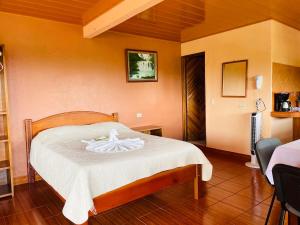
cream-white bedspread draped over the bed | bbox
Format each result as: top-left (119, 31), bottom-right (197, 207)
top-left (30, 122), bottom-right (212, 224)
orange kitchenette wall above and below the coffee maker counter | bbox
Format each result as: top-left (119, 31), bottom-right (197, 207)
top-left (271, 21), bottom-right (300, 142)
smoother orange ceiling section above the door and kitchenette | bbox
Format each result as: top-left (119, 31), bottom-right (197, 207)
top-left (181, 0), bottom-right (300, 42)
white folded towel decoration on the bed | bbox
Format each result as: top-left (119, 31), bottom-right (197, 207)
top-left (82, 129), bottom-right (144, 153)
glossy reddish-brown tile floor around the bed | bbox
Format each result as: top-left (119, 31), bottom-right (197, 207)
top-left (0, 152), bottom-right (288, 225)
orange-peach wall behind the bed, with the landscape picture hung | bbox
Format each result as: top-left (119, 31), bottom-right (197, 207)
top-left (0, 13), bottom-right (182, 176)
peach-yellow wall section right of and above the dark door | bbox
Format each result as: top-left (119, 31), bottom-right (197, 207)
top-left (181, 21), bottom-right (272, 154)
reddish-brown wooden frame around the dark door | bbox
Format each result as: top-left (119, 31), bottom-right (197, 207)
top-left (181, 51), bottom-right (207, 143)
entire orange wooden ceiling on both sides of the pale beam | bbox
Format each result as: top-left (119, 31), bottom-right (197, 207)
top-left (0, 0), bottom-right (300, 42)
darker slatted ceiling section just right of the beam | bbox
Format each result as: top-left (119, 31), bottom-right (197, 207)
top-left (112, 0), bottom-right (205, 41)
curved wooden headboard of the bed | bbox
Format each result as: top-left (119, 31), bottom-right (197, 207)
top-left (24, 111), bottom-right (118, 183)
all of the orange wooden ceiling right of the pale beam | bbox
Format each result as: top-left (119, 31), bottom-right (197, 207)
top-left (113, 0), bottom-right (300, 42)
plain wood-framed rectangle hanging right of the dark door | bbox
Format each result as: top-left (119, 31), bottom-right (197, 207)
top-left (222, 60), bottom-right (248, 98)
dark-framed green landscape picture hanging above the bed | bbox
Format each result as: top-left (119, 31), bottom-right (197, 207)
top-left (126, 49), bottom-right (158, 82)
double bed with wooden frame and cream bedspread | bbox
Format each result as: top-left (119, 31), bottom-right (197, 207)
top-left (25, 111), bottom-right (212, 224)
